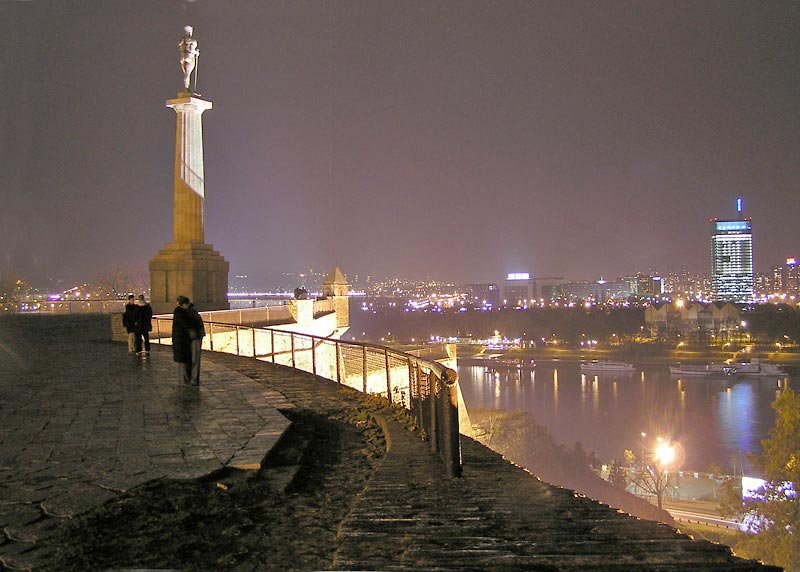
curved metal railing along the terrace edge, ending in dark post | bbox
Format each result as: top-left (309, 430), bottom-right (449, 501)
top-left (150, 317), bottom-right (461, 477)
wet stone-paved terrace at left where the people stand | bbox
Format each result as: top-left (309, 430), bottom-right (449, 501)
top-left (0, 317), bottom-right (289, 569)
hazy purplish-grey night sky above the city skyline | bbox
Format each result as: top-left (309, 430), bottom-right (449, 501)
top-left (0, 0), bottom-right (800, 281)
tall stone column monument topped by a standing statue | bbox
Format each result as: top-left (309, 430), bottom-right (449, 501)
top-left (150, 26), bottom-right (230, 313)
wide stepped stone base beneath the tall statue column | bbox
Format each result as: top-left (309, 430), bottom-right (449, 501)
top-left (150, 242), bottom-right (230, 314)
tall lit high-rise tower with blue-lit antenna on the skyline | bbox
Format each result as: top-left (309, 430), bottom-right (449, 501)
top-left (710, 199), bottom-right (753, 303)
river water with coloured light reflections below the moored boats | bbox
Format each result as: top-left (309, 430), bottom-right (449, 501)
top-left (458, 361), bottom-right (793, 471)
